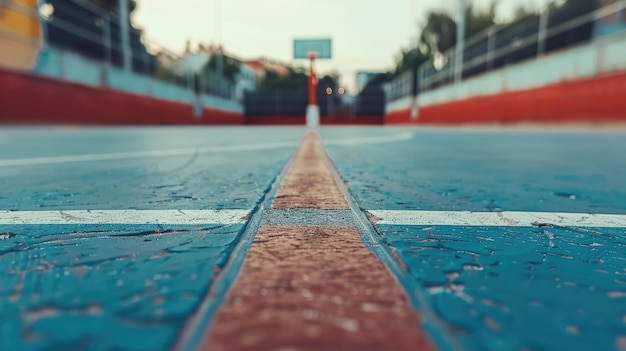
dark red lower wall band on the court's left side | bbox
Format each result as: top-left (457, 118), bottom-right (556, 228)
top-left (0, 70), bottom-right (244, 125)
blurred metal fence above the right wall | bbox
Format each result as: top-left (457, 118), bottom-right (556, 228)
top-left (387, 0), bottom-right (626, 101)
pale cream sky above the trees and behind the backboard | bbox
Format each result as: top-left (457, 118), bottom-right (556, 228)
top-left (133, 0), bottom-right (547, 93)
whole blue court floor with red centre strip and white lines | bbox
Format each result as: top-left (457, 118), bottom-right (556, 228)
top-left (0, 127), bottom-right (626, 350)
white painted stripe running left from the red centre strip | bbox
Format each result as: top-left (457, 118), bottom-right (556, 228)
top-left (0, 210), bottom-right (250, 225)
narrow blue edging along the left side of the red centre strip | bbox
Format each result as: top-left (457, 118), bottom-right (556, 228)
top-left (171, 131), bottom-right (304, 351)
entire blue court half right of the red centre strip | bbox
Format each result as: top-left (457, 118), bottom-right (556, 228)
top-left (322, 128), bottom-right (626, 351)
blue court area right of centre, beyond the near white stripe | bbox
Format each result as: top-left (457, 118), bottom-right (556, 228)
top-left (320, 128), bottom-right (626, 214)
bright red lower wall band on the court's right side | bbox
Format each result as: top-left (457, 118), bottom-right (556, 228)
top-left (385, 73), bottom-right (626, 124)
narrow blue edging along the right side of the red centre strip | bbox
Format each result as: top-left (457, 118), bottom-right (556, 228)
top-left (322, 140), bottom-right (463, 351)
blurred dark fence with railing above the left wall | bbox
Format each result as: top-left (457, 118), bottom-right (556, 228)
top-left (0, 0), bottom-right (233, 98)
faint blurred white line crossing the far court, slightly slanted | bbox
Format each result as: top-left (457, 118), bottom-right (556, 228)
top-left (0, 132), bottom-right (413, 167)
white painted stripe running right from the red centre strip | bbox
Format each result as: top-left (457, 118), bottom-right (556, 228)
top-left (368, 210), bottom-right (626, 228)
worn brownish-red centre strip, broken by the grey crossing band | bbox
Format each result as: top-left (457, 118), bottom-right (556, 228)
top-left (200, 132), bottom-right (434, 351)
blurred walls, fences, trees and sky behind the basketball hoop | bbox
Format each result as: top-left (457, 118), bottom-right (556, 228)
top-left (0, 0), bottom-right (626, 125)
